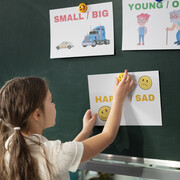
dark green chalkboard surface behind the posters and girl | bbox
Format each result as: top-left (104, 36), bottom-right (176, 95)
top-left (0, 0), bottom-right (180, 161)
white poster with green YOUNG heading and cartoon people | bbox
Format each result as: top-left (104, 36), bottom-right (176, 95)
top-left (122, 0), bottom-right (180, 50)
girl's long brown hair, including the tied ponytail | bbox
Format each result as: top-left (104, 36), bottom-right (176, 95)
top-left (0, 77), bottom-right (50, 180)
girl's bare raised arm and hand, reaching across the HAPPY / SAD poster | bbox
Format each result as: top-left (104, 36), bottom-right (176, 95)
top-left (81, 70), bottom-right (134, 162)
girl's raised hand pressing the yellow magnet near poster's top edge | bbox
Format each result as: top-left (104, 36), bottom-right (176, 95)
top-left (113, 70), bottom-right (135, 102)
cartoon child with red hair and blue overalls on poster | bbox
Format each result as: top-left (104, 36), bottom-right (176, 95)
top-left (137, 13), bottom-right (150, 45)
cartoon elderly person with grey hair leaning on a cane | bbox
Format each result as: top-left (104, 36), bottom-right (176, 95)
top-left (166, 10), bottom-right (180, 45)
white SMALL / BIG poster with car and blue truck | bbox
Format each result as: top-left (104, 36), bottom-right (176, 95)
top-left (50, 2), bottom-right (114, 59)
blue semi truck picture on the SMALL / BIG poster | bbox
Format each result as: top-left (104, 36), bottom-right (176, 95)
top-left (82, 26), bottom-right (110, 47)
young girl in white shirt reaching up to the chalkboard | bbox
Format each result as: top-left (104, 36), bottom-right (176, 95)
top-left (0, 70), bottom-right (134, 180)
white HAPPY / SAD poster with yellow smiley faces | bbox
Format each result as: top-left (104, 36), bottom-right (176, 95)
top-left (88, 71), bottom-right (162, 126)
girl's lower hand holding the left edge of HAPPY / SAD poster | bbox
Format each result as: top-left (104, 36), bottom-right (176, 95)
top-left (82, 109), bottom-right (97, 136)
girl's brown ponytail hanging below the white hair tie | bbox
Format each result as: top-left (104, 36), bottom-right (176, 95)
top-left (8, 130), bottom-right (41, 180)
